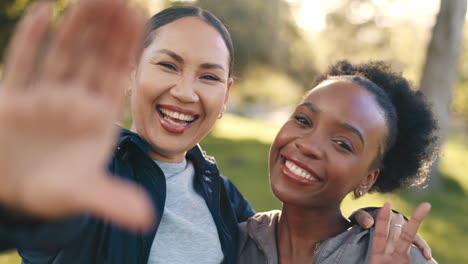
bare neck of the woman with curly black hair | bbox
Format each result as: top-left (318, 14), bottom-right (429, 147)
top-left (276, 204), bottom-right (350, 263)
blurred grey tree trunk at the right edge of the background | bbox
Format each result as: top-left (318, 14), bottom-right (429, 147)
top-left (419, 0), bottom-right (467, 189)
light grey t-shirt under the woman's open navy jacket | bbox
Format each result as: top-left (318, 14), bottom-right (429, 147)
top-left (148, 160), bottom-right (224, 264)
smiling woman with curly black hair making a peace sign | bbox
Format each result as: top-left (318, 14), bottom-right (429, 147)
top-left (239, 61), bottom-right (437, 264)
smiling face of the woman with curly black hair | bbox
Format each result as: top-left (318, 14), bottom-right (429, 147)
top-left (269, 80), bottom-right (387, 207)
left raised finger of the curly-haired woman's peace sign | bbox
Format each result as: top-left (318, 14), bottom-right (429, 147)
top-left (372, 202), bottom-right (391, 254)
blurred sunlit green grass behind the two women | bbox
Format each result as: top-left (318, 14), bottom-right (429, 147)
top-left (0, 115), bottom-right (468, 264)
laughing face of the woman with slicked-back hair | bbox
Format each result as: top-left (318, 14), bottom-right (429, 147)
top-left (131, 17), bottom-right (232, 162)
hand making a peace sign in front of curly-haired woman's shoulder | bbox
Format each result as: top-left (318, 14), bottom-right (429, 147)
top-left (369, 203), bottom-right (431, 264)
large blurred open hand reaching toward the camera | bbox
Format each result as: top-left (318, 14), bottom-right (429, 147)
top-left (0, 0), bottom-right (154, 230)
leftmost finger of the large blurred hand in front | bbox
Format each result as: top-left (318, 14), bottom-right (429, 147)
top-left (4, 1), bottom-right (52, 91)
